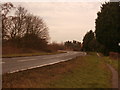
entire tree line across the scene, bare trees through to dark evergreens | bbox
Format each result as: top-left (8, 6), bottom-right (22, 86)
top-left (0, 2), bottom-right (120, 55)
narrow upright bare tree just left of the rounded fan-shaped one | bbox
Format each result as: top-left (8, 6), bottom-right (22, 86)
top-left (9, 6), bottom-right (27, 39)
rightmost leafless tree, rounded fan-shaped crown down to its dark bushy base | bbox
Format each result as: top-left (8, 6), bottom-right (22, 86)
top-left (23, 14), bottom-right (49, 49)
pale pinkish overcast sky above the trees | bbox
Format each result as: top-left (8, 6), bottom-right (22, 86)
top-left (11, 1), bottom-right (107, 42)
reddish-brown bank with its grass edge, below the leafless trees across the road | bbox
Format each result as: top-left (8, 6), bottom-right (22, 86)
top-left (2, 46), bottom-right (66, 58)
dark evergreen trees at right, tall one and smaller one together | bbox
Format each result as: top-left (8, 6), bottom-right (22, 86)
top-left (82, 2), bottom-right (120, 55)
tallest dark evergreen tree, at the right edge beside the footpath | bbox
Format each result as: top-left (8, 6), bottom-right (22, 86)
top-left (95, 2), bottom-right (120, 54)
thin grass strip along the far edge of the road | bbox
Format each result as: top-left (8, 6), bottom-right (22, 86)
top-left (2, 52), bottom-right (66, 58)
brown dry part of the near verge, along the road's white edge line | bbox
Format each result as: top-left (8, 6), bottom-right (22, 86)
top-left (3, 57), bottom-right (84, 88)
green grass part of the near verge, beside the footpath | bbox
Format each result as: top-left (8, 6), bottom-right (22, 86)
top-left (50, 53), bottom-right (111, 88)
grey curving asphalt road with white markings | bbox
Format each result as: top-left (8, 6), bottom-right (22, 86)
top-left (2, 51), bottom-right (85, 74)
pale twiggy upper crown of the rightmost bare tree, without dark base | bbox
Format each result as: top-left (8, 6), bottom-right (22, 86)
top-left (26, 14), bottom-right (49, 40)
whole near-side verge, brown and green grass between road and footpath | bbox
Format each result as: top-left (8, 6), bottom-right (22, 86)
top-left (2, 54), bottom-right (112, 88)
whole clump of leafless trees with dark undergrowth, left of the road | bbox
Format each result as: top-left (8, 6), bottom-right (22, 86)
top-left (0, 3), bottom-right (49, 50)
